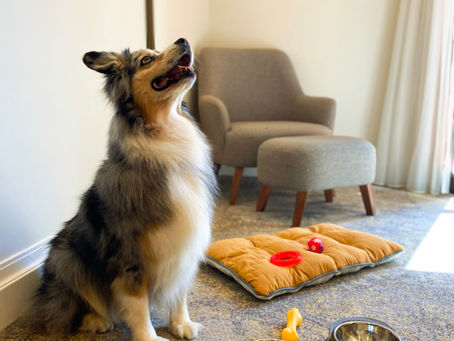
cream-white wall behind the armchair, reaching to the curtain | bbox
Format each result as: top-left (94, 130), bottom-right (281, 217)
top-left (204, 0), bottom-right (399, 143)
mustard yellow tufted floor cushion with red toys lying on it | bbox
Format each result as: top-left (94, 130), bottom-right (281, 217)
top-left (207, 223), bottom-right (403, 300)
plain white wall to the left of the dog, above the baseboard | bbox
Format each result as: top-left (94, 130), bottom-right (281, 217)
top-left (0, 0), bottom-right (146, 314)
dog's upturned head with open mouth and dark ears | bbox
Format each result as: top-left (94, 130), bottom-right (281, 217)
top-left (83, 38), bottom-right (195, 127)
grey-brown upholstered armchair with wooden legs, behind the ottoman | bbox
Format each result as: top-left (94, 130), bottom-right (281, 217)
top-left (198, 48), bottom-right (336, 205)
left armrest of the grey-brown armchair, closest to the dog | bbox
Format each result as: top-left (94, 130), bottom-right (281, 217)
top-left (199, 95), bottom-right (230, 155)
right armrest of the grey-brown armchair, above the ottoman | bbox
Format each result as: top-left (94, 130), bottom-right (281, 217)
top-left (293, 94), bottom-right (336, 129)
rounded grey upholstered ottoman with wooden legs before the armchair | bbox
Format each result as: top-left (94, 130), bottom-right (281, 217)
top-left (256, 135), bottom-right (375, 226)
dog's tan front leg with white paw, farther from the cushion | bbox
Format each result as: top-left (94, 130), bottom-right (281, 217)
top-left (112, 280), bottom-right (169, 341)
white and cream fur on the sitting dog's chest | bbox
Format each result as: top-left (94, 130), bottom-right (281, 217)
top-left (142, 112), bottom-right (212, 304)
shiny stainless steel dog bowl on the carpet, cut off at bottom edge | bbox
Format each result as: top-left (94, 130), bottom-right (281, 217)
top-left (329, 317), bottom-right (401, 341)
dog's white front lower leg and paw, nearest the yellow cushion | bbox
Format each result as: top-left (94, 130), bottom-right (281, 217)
top-left (170, 292), bottom-right (203, 339)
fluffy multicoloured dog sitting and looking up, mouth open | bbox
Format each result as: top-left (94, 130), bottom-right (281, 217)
top-left (32, 38), bottom-right (217, 341)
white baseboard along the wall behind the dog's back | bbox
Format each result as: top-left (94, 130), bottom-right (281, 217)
top-left (0, 237), bottom-right (52, 330)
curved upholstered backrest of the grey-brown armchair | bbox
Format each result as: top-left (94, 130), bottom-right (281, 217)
top-left (198, 47), bottom-right (302, 122)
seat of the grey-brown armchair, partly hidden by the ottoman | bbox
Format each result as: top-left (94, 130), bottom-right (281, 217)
top-left (222, 121), bottom-right (332, 167)
